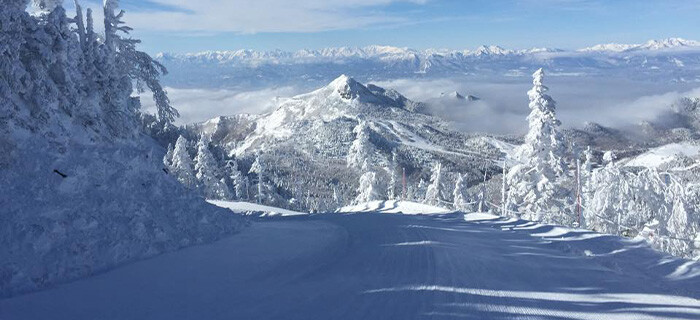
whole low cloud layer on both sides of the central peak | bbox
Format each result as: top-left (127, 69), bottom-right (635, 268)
top-left (142, 76), bottom-right (700, 134)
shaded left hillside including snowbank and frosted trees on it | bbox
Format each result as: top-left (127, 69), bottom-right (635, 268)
top-left (0, 1), bottom-right (245, 298)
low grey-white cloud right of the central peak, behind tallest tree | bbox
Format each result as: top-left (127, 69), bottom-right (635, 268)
top-left (370, 76), bottom-right (700, 134)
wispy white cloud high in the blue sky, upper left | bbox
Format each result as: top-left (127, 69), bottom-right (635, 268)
top-left (111, 0), bottom-right (428, 34)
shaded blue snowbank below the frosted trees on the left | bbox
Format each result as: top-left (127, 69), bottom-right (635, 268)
top-left (0, 137), bottom-right (245, 297)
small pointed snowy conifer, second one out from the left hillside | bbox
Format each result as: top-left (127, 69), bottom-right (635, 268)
top-left (194, 135), bottom-right (231, 199)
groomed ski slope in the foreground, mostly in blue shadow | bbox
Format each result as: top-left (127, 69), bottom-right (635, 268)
top-left (0, 205), bottom-right (700, 320)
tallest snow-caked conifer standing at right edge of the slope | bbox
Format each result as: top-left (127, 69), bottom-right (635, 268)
top-left (507, 69), bottom-right (573, 225)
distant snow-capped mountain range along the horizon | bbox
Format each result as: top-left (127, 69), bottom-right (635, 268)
top-left (157, 38), bottom-right (700, 88)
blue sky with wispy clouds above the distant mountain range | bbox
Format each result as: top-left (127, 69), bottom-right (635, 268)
top-left (72, 0), bottom-right (700, 53)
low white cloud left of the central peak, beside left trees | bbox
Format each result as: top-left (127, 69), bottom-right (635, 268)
top-left (141, 86), bottom-right (300, 124)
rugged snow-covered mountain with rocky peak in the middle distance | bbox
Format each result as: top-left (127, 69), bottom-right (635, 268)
top-left (185, 75), bottom-right (502, 211)
